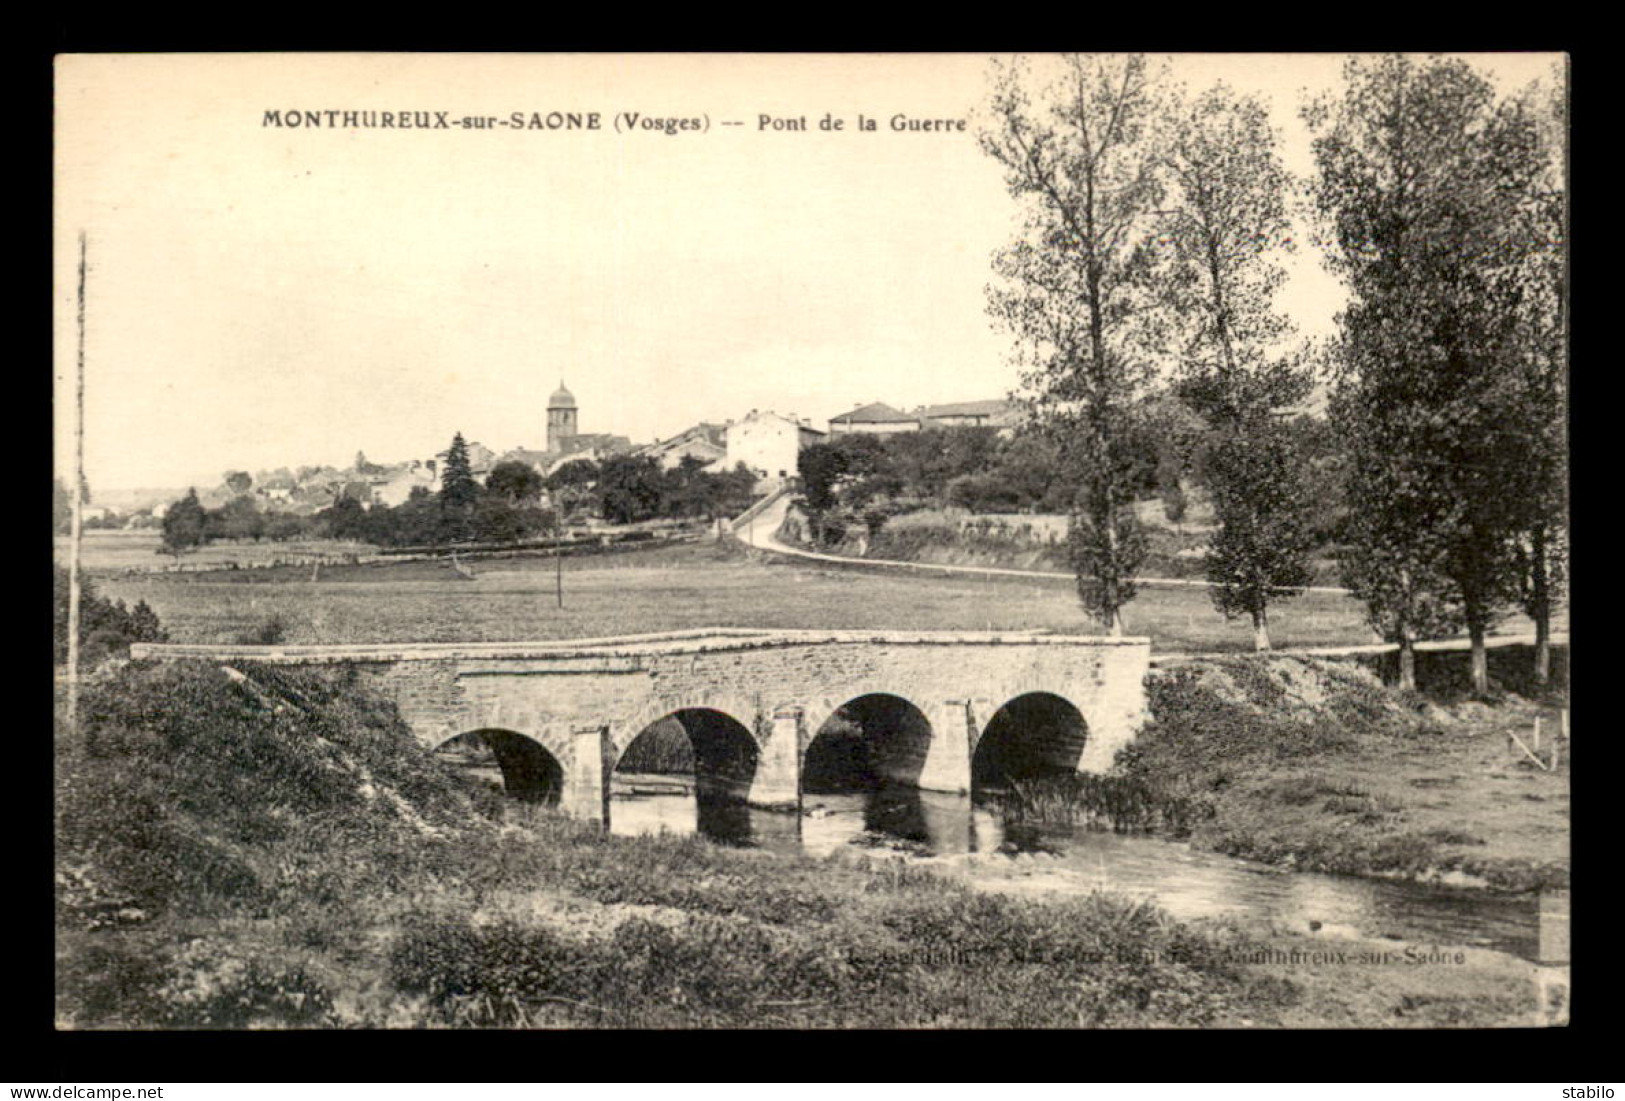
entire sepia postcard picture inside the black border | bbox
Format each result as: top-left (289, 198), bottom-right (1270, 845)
top-left (50, 52), bottom-right (1584, 1032)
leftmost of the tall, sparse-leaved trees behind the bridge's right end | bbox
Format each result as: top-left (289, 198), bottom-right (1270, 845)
top-left (980, 55), bottom-right (1162, 633)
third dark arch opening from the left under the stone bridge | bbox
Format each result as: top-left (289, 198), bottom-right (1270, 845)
top-left (801, 692), bottom-right (933, 792)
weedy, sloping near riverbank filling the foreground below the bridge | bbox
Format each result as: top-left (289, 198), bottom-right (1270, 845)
top-left (57, 663), bottom-right (1536, 1028)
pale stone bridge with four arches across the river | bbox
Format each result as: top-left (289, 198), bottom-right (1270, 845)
top-left (132, 628), bottom-right (1151, 822)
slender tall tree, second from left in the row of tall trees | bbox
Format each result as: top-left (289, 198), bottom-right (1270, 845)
top-left (1162, 84), bottom-right (1313, 650)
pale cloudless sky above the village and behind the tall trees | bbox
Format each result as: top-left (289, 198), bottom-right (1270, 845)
top-left (54, 54), bottom-right (1557, 495)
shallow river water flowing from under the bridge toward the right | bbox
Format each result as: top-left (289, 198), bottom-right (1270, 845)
top-left (611, 784), bottom-right (1537, 958)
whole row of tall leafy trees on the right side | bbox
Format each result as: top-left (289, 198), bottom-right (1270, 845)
top-left (978, 55), bottom-right (1567, 692)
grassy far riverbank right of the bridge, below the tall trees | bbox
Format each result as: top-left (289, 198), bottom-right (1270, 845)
top-left (1115, 646), bottom-right (1571, 892)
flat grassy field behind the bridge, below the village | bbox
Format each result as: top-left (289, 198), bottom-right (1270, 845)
top-left (85, 544), bottom-right (1372, 651)
